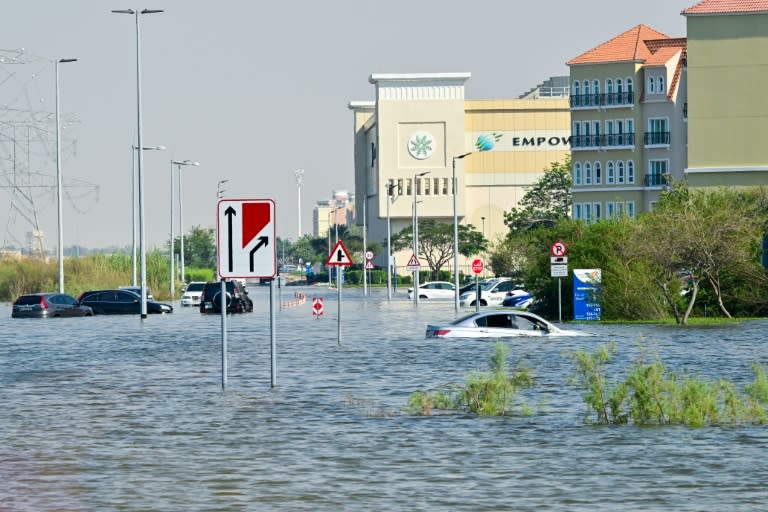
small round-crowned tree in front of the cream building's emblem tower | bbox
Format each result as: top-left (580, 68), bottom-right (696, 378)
top-left (392, 219), bottom-right (488, 279)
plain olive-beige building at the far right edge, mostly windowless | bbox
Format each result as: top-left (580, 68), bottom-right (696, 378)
top-left (682, 0), bottom-right (768, 186)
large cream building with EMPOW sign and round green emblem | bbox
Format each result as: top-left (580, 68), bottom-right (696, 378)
top-left (349, 73), bottom-right (570, 272)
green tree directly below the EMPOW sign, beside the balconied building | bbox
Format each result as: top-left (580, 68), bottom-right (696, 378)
top-left (504, 155), bottom-right (572, 236)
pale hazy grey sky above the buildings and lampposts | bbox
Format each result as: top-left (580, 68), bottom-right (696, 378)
top-left (0, 0), bottom-right (697, 249)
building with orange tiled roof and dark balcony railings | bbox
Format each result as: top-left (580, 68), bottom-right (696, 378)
top-left (566, 25), bottom-right (687, 222)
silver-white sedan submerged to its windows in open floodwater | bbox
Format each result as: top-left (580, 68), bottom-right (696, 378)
top-left (427, 309), bottom-right (594, 338)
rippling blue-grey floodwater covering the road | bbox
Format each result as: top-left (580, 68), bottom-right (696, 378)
top-left (0, 286), bottom-right (768, 511)
